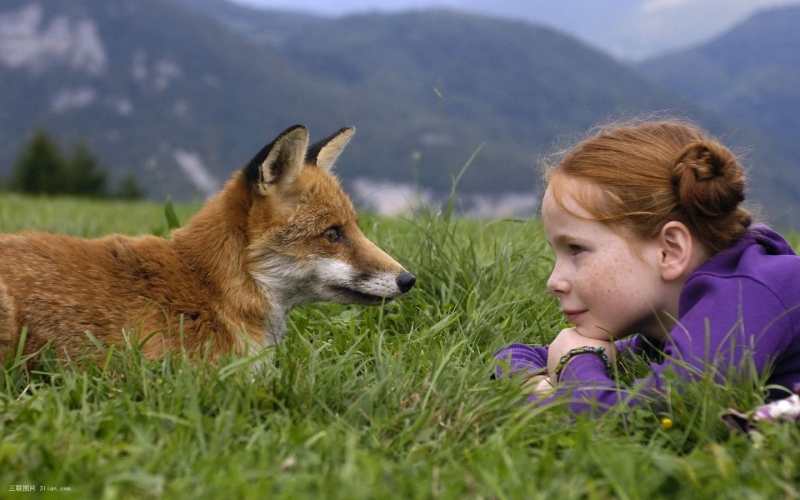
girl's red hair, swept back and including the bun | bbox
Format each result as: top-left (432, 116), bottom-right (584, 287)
top-left (545, 120), bottom-right (753, 254)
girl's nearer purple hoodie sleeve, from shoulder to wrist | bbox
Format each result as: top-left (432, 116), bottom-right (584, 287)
top-left (547, 275), bottom-right (793, 412)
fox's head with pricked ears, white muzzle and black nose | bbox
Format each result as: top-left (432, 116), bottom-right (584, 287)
top-left (243, 125), bottom-right (416, 307)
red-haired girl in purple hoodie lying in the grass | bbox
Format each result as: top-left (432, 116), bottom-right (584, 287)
top-left (496, 121), bottom-right (800, 412)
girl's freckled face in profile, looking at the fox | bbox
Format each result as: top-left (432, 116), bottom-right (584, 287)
top-left (542, 189), bottom-right (678, 340)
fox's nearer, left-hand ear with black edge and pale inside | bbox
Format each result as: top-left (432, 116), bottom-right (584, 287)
top-left (244, 125), bottom-right (308, 194)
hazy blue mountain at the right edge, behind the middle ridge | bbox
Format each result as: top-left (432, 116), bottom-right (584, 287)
top-left (637, 6), bottom-right (800, 227)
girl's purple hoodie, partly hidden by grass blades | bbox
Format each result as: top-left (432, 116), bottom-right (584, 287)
top-left (495, 225), bottom-right (800, 412)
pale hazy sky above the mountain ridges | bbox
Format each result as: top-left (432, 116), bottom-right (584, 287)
top-left (232, 0), bottom-right (800, 59)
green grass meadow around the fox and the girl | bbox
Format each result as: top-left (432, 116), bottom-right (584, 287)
top-left (0, 196), bottom-right (800, 499)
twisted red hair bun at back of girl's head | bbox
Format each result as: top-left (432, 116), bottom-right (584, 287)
top-left (671, 140), bottom-right (745, 218)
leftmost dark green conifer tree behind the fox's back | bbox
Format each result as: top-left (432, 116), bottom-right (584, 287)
top-left (11, 129), bottom-right (66, 195)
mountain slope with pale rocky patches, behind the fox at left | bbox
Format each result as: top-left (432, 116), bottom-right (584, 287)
top-left (0, 0), bottom-right (412, 199)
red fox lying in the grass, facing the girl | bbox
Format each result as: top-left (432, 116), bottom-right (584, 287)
top-left (0, 125), bottom-right (416, 363)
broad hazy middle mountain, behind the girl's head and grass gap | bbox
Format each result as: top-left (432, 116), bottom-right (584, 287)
top-left (167, 0), bottom-right (800, 227)
